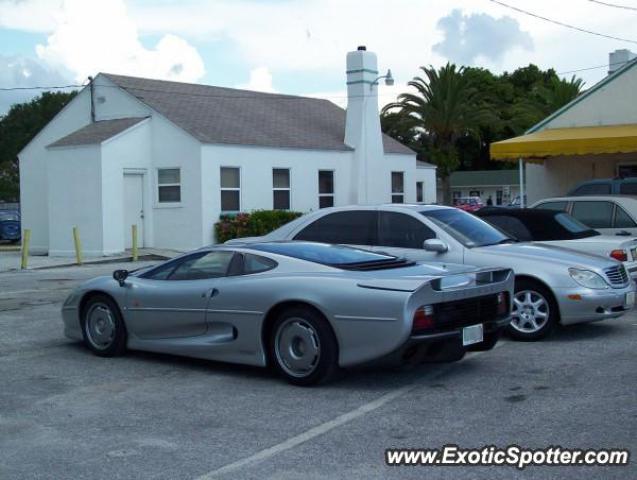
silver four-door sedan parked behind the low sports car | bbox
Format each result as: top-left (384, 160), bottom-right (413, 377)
top-left (235, 205), bottom-right (635, 340)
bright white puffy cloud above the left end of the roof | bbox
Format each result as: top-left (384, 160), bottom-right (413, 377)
top-left (0, 0), bottom-right (205, 82)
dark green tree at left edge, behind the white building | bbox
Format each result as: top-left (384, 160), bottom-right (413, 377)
top-left (0, 92), bottom-right (76, 202)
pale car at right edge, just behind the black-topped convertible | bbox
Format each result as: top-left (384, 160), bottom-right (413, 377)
top-left (531, 195), bottom-right (637, 236)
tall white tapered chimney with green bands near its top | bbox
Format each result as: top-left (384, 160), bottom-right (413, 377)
top-left (345, 47), bottom-right (391, 205)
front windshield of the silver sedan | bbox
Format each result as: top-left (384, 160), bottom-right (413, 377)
top-left (421, 208), bottom-right (516, 248)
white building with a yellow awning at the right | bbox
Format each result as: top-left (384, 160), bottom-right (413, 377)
top-left (491, 50), bottom-right (637, 204)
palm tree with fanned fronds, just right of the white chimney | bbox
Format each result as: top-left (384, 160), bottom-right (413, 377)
top-left (383, 63), bottom-right (486, 204)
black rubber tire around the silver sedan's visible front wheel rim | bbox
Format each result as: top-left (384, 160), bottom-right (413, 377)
top-left (506, 278), bottom-right (559, 342)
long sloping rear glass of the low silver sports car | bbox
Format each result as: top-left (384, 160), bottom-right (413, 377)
top-left (250, 242), bottom-right (403, 267)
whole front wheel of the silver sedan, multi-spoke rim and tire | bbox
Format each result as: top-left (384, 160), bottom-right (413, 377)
top-left (507, 279), bottom-right (558, 341)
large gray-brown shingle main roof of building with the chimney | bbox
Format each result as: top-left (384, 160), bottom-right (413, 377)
top-left (102, 74), bottom-right (414, 155)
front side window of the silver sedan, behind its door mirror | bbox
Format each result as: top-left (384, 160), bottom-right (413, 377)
top-left (378, 212), bottom-right (436, 248)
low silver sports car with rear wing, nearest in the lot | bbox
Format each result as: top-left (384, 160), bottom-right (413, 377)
top-left (62, 242), bottom-right (513, 385)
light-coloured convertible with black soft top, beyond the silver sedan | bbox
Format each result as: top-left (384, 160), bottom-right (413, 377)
top-left (475, 207), bottom-right (637, 278)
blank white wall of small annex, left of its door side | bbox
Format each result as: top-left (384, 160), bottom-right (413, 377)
top-left (46, 145), bottom-right (103, 256)
